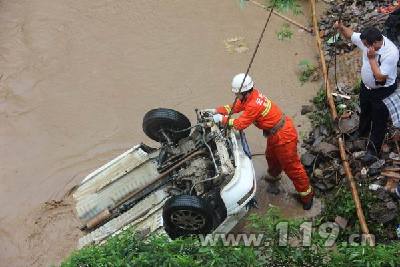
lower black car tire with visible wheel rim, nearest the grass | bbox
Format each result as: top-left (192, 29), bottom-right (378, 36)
top-left (163, 195), bottom-right (214, 239)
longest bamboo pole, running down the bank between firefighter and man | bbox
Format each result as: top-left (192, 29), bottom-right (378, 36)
top-left (310, 0), bottom-right (375, 245)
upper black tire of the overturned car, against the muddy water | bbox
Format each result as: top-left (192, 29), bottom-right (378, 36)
top-left (142, 108), bottom-right (191, 143)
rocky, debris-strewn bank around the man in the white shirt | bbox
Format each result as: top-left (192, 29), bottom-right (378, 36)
top-left (301, 1), bottom-right (400, 241)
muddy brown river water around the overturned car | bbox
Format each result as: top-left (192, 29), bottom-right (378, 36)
top-left (0, 0), bottom-right (319, 266)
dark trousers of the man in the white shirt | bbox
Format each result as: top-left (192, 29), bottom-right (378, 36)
top-left (358, 82), bottom-right (397, 154)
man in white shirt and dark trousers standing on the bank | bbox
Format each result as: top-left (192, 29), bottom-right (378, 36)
top-left (334, 21), bottom-right (399, 163)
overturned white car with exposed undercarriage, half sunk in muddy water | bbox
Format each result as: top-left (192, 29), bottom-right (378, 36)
top-left (73, 108), bottom-right (256, 247)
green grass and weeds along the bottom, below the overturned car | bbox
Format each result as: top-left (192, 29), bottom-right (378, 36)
top-left (61, 207), bottom-right (400, 267)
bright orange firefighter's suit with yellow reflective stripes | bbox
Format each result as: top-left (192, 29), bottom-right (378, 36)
top-left (217, 89), bottom-right (313, 203)
